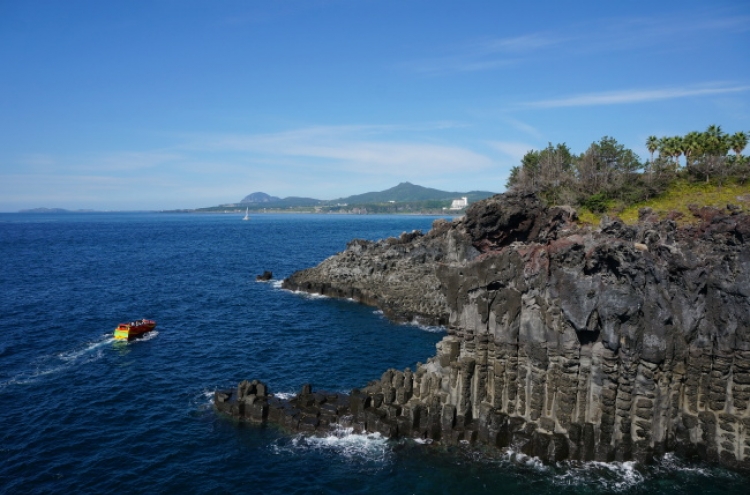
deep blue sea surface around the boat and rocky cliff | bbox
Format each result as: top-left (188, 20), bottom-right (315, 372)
top-left (0, 213), bottom-right (750, 495)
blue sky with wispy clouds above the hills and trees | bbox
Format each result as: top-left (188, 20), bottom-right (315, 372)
top-left (0, 0), bottom-right (750, 211)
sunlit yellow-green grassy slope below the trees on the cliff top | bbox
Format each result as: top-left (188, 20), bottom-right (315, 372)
top-left (578, 180), bottom-right (750, 225)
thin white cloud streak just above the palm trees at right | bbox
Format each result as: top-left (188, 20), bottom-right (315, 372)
top-left (521, 86), bottom-right (750, 108)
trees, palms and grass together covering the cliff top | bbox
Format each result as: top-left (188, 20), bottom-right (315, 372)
top-left (506, 125), bottom-right (750, 223)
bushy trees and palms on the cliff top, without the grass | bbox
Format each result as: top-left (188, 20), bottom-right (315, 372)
top-left (506, 125), bottom-right (750, 212)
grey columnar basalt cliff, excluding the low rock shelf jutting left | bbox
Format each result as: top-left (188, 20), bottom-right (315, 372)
top-left (270, 195), bottom-right (750, 467)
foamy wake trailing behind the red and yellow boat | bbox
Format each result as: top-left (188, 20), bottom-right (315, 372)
top-left (0, 333), bottom-right (115, 390)
